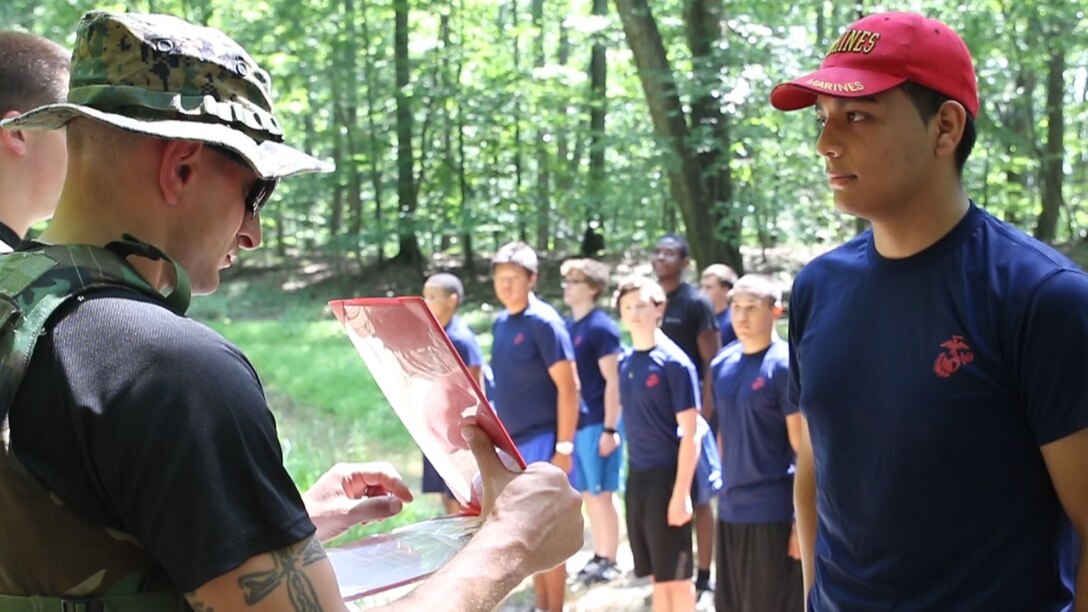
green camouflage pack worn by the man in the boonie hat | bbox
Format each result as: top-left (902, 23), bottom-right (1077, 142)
top-left (0, 237), bottom-right (189, 612)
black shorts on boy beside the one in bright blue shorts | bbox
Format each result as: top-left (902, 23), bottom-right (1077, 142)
top-left (626, 466), bottom-right (694, 583)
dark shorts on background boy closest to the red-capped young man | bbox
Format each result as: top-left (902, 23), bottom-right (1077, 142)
top-left (714, 521), bottom-right (804, 612)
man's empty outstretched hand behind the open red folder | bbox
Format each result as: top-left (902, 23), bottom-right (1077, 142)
top-left (302, 462), bottom-right (412, 541)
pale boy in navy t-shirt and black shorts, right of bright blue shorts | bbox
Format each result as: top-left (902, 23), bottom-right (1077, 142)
top-left (613, 278), bottom-right (700, 612)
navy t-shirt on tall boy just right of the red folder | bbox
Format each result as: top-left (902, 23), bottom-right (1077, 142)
top-left (491, 297), bottom-right (574, 439)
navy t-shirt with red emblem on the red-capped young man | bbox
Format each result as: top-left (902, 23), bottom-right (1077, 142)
top-left (790, 205), bottom-right (1088, 611)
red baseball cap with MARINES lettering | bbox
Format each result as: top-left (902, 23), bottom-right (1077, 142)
top-left (770, 13), bottom-right (978, 118)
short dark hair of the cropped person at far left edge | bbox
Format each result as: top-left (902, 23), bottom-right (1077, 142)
top-left (0, 30), bottom-right (71, 114)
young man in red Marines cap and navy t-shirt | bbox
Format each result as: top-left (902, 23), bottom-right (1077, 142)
top-left (770, 13), bottom-right (1088, 610)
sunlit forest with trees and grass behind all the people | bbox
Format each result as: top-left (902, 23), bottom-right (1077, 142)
top-left (0, 0), bottom-right (1088, 601)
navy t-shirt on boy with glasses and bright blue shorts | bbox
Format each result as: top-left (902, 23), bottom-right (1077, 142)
top-left (567, 308), bottom-right (622, 429)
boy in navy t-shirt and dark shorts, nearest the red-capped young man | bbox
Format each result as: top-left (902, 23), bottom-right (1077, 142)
top-left (710, 274), bottom-right (804, 612)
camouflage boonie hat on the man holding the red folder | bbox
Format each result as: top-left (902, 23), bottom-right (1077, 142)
top-left (0, 11), bottom-right (333, 179)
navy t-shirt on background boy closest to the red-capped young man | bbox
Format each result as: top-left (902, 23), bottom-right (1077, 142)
top-left (710, 338), bottom-right (798, 523)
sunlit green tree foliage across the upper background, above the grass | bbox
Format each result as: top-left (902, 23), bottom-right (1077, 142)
top-left (10, 0), bottom-right (1088, 252)
